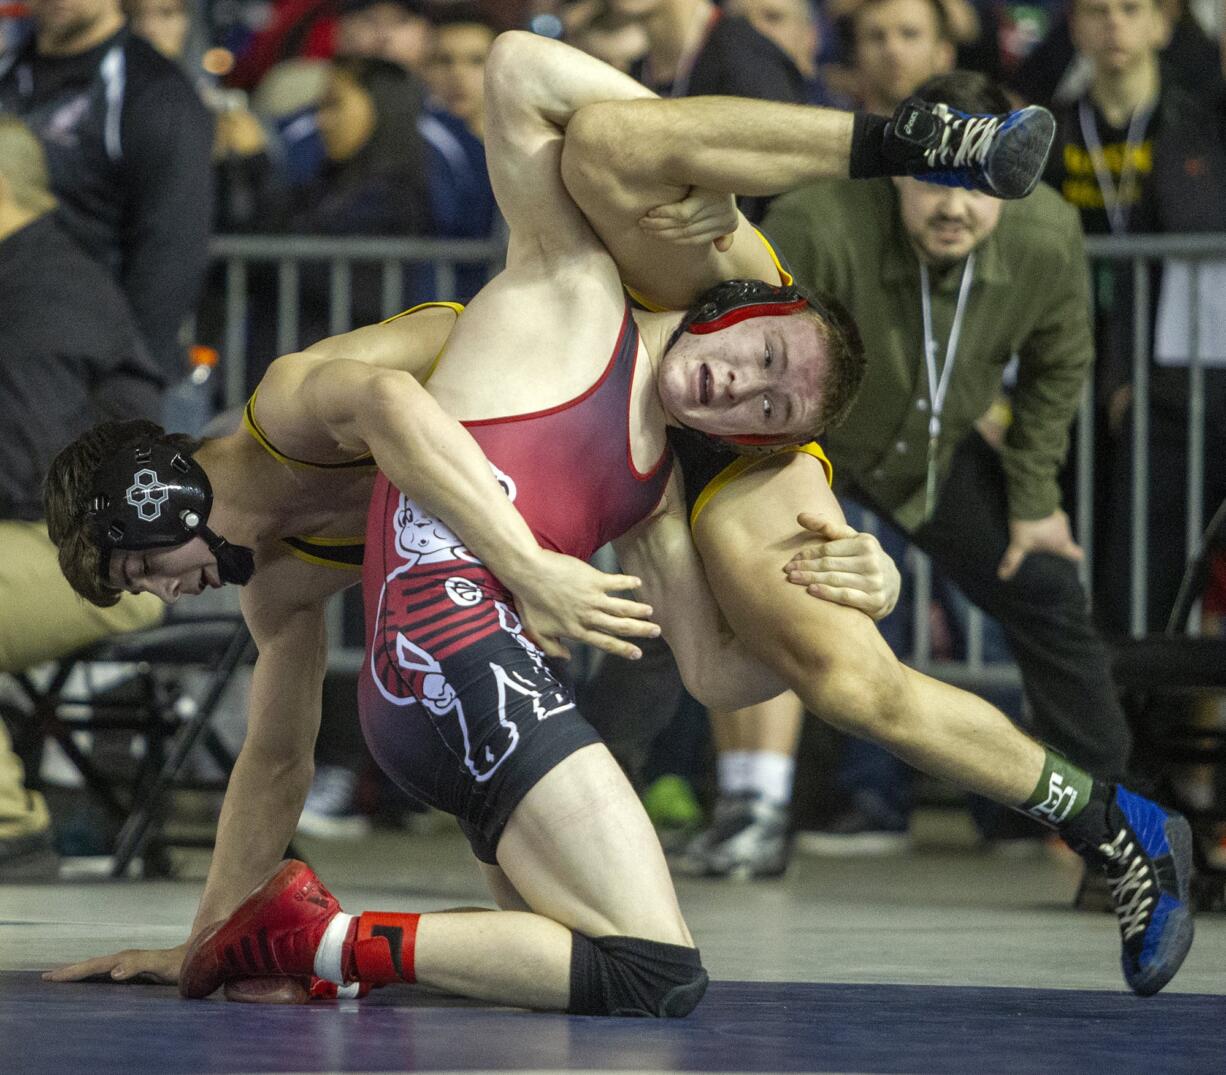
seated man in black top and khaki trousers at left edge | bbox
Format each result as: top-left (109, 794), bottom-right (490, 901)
top-left (0, 115), bottom-right (163, 881)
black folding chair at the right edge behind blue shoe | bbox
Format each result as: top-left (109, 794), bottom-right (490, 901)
top-left (1113, 503), bottom-right (1226, 910)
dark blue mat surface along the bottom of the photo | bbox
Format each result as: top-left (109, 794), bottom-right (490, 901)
top-left (0, 972), bottom-right (1226, 1075)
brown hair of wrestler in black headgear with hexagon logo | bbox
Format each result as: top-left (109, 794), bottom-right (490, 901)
top-left (43, 418), bottom-right (201, 608)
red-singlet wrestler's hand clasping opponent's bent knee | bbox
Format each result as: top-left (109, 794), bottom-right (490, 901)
top-left (783, 511), bottom-right (902, 620)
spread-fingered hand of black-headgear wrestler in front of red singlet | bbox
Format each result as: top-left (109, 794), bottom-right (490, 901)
top-left (511, 549), bottom-right (660, 661)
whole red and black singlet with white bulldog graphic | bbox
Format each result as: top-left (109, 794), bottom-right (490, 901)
top-left (359, 297), bottom-right (669, 862)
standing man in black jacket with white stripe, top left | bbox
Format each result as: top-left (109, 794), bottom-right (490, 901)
top-left (0, 0), bottom-right (213, 380)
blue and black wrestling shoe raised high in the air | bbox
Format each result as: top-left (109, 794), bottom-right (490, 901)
top-left (886, 97), bottom-right (1056, 199)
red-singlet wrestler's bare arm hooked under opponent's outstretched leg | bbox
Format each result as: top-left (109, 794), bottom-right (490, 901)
top-left (613, 471), bottom-right (786, 708)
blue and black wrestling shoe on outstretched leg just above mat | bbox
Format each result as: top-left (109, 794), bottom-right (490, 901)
top-left (1074, 786), bottom-right (1193, 997)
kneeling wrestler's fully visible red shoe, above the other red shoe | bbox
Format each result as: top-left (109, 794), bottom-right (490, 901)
top-left (179, 859), bottom-right (341, 998)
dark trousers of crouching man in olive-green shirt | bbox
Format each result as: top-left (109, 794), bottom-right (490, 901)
top-left (885, 433), bottom-right (1132, 780)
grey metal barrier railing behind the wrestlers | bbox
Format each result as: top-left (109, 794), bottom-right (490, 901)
top-left (201, 234), bottom-right (1226, 688)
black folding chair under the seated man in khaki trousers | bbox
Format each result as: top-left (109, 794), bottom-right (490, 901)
top-left (10, 613), bottom-right (255, 878)
